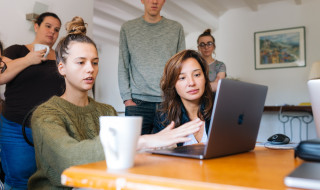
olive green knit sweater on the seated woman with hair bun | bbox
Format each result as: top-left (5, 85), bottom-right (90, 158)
top-left (28, 96), bottom-right (117, 190)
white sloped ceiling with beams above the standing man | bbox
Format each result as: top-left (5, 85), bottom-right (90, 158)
top-left (93, 0), bottom-right (302, 45)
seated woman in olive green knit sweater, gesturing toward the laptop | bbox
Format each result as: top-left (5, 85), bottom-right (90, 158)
top-left (28, 17), bottom-right (204, 190)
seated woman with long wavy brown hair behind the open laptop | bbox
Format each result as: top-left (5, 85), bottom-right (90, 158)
top-left (153, 50), bottom-right (213, 146)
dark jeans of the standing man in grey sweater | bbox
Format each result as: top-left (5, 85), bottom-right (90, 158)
top-left (125, 99), bottom-right (160, 135)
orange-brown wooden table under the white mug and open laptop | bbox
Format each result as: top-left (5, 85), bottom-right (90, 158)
top-left (62, 147), bottom-right (303, 190)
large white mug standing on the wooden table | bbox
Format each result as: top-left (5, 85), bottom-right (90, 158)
top-left (99, 116), bottom-right (142, 170)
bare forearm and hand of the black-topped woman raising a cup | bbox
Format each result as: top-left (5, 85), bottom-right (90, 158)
top-left (0, 50), bottom-right (46, 85)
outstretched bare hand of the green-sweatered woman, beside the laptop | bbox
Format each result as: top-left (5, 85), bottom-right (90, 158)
top-left (137, 118), bottom-right (204, 150)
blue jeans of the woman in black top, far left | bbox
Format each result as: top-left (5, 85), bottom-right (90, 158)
top-left (0, 115), bottom-right (37, 190)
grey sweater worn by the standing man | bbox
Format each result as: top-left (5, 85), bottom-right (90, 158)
top-left (118, 17), bottom-right (185, 102)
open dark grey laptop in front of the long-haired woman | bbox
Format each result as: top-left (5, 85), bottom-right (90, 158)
top-left (149, 79), bottom-right (268, 159)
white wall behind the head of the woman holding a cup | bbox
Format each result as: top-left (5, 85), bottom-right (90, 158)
top-left (0, 0), bottom-right (93, 98)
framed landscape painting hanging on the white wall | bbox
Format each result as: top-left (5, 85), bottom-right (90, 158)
top-left (254, 26), bottom-right (306, 70)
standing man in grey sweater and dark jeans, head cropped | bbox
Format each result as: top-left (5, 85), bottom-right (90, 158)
top-left (118, 0), bottom-right (185, 134)
